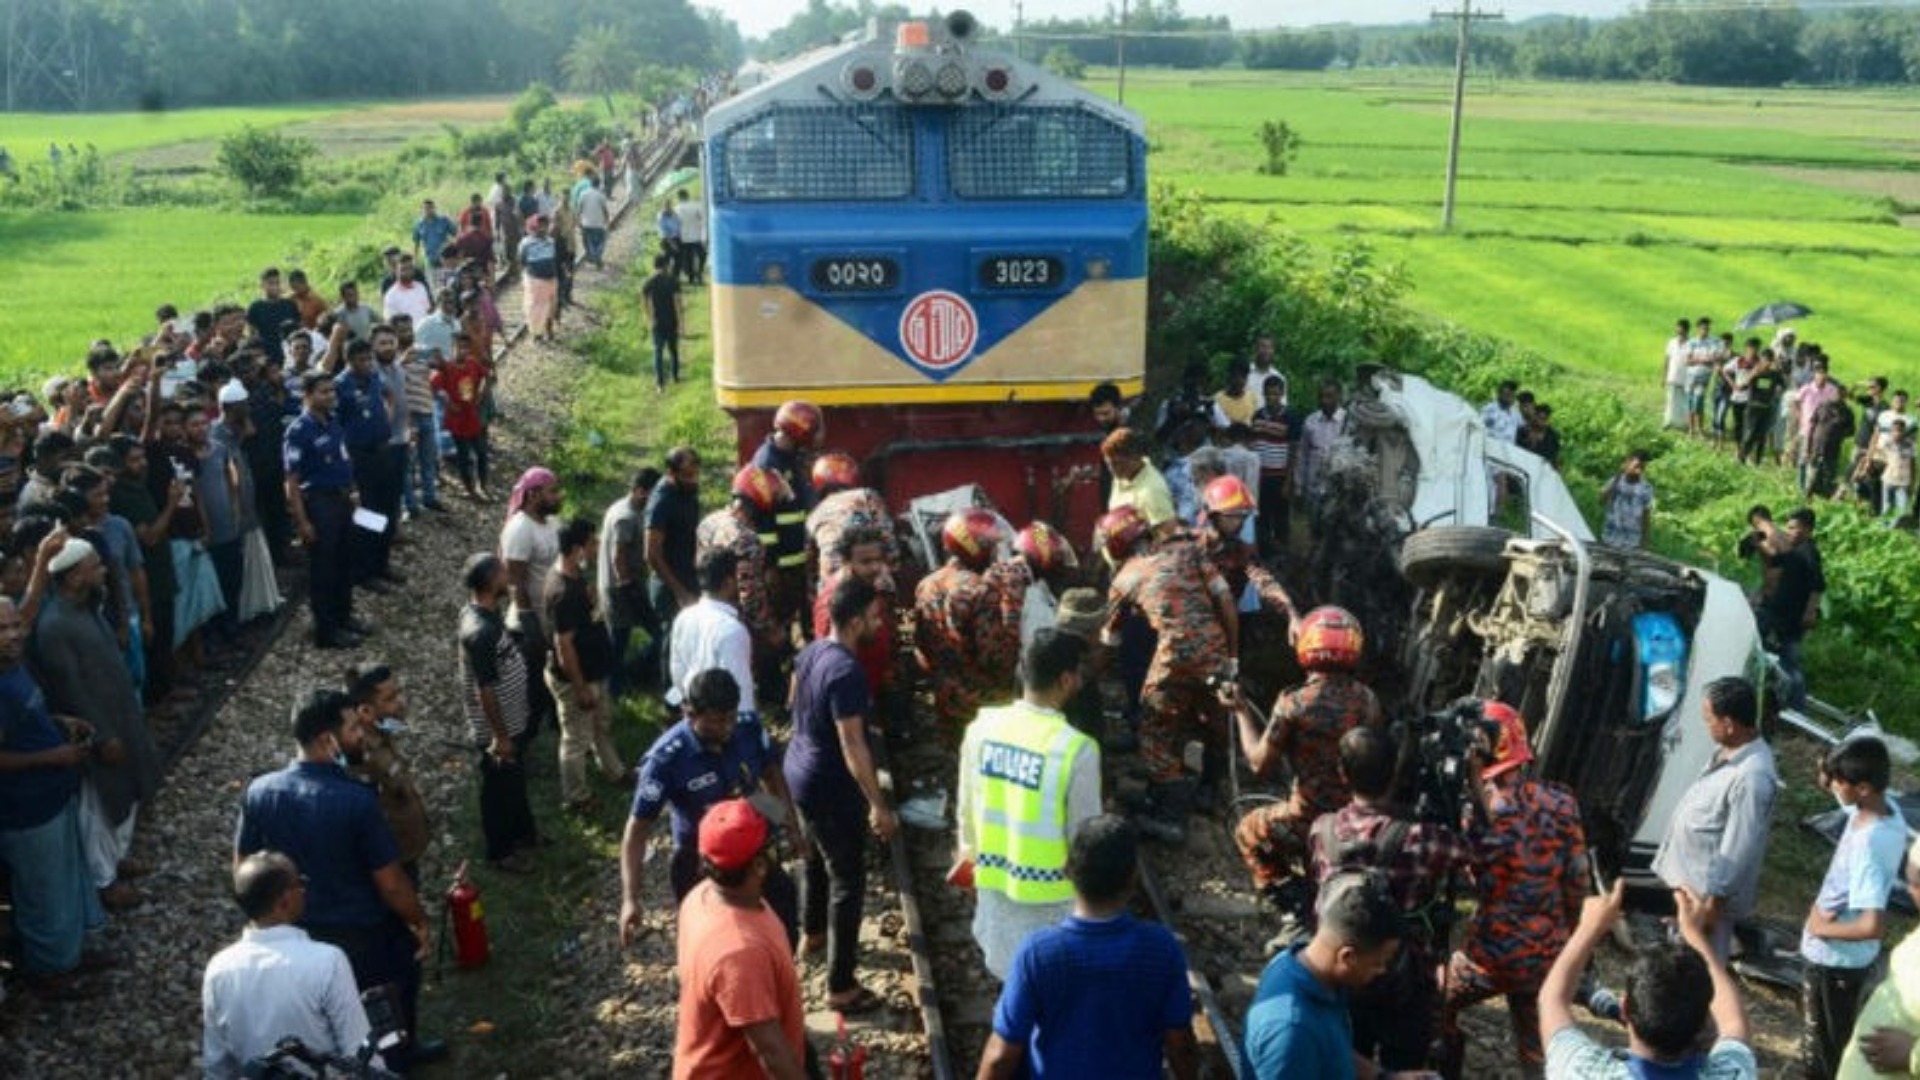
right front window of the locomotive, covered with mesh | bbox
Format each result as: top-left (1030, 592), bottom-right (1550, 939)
top-left (947, 106), bottom-right (1133, 198)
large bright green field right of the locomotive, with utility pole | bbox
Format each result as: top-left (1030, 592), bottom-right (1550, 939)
top-left (1094, 71), bottom-right (1920, 405)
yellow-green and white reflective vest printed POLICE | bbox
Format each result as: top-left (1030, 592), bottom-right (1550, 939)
top-left (968, 701), bottom-right (1092, 903)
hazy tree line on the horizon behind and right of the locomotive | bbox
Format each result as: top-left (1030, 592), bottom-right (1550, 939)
top-left (753, 0), bottom-right (1920, 86)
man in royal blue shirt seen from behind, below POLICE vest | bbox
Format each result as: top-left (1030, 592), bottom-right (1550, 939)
top-left (979, 815), bottom-right (1190, 1080)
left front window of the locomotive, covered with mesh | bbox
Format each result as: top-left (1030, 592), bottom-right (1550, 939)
top-left (720, 106), bottom-right (914, 202)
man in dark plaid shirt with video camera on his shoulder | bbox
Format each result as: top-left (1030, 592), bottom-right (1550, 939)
top-left (1311, 726), bottom-right (1478, 1070)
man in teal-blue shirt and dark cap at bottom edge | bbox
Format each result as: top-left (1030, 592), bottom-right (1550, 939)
top-left (1246, 871), bottom-right (1407, 1080)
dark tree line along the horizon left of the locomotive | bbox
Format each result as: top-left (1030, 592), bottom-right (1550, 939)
top-left (0, 0), bottom-right (745, 111)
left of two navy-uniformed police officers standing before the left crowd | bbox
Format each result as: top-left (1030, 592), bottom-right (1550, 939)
top-left (282, 369), bottom-right (367, 650)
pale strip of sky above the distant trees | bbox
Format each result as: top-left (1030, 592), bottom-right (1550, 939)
top-left (714, 0), bottom-right (1632, 37)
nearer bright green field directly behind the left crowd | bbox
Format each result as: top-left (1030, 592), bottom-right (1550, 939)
top-left (0, 209), bottom-right (359, 384)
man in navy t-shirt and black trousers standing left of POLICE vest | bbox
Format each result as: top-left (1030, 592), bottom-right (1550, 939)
top-left (785, 575), bottom-right (900, 1013)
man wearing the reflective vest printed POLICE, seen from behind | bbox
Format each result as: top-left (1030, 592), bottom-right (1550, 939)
top-left (954, 628), bottom-right (1100, 980)
